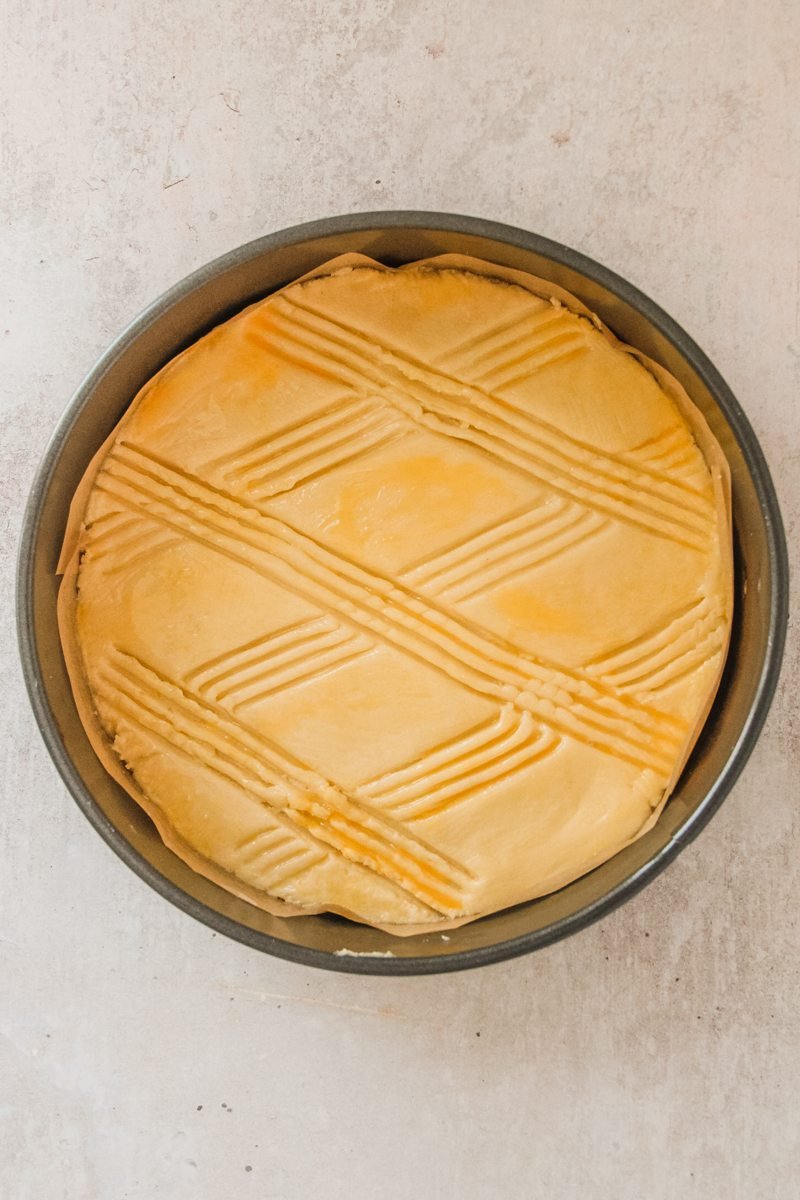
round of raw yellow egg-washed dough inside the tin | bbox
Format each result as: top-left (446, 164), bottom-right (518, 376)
top-left (60, 264), bottom-right (730, 932)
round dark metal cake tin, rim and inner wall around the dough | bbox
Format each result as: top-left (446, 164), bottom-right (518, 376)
top-left (17, 211), bottom-right (788, 974)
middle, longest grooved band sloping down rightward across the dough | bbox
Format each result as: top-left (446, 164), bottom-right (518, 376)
top-left (97, 444), bottom-right (682, 772)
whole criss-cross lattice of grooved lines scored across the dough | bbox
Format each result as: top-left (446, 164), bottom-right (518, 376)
top-left (89, 283), bottom-right (724, 916)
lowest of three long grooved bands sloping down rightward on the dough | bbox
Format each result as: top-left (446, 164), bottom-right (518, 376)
top-left (106, 652), bottom-right (469, 914)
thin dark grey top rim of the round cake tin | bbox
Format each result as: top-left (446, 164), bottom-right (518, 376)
top-left (17, 210), bottom-right (789, 976)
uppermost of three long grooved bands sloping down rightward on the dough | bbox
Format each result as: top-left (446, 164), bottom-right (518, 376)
top-left (270, 298), bottom-right (711, 539)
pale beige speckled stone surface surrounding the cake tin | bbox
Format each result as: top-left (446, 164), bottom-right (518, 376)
top-left (0, 0), bottom-right (800, 1200)
